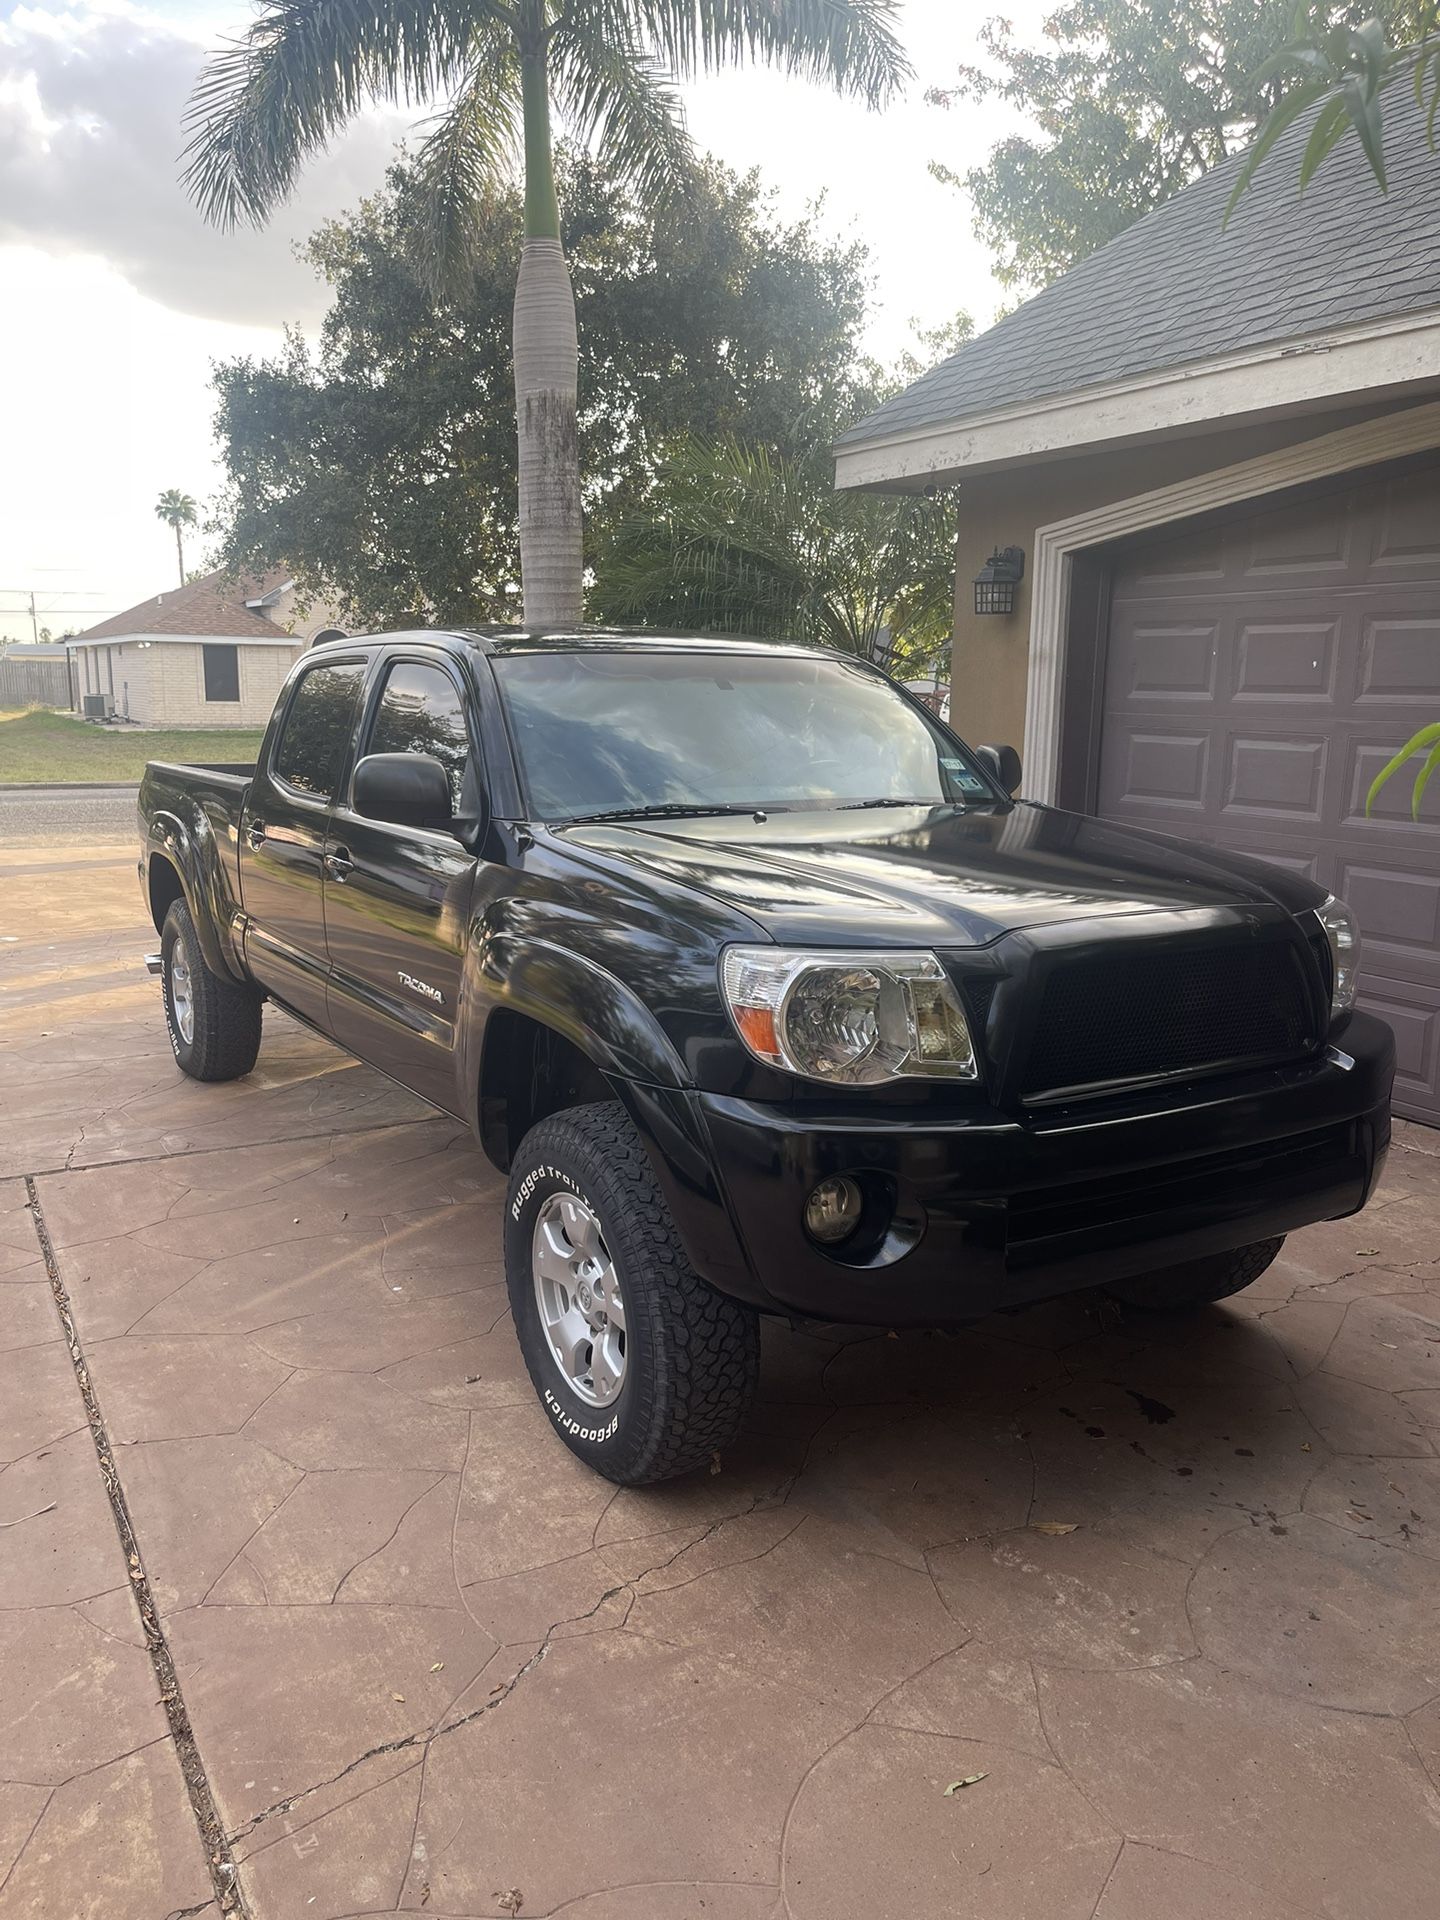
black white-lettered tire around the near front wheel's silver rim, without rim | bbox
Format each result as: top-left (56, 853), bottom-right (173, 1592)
top-left (505, 1102), bottom-right (760, 1486)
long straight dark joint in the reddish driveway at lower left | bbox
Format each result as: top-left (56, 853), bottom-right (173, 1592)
top-left (25, 1173), bottom-right (250, 1920)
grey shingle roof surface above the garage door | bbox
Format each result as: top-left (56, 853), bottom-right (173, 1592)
top-left (839, 77), bottom-right (1440, 447)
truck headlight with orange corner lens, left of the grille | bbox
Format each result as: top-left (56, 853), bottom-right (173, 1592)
top-left (720, 947), bottom-right (975, 1087)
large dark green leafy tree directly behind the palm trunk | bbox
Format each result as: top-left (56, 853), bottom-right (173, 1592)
top-left (205, 156), bottom-right (870, 628)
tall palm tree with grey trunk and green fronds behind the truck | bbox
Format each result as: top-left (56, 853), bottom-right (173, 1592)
top-left (184, 0), bottom-right (910, 626)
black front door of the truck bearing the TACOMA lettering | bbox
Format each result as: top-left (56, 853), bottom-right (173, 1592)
top-left (324, 651), bottom-right (478, 1114)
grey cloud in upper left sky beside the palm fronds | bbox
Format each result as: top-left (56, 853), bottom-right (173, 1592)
top-left (0, 0), bottom-right (414, 326)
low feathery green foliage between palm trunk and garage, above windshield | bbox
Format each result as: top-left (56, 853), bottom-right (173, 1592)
top-left (593, 438), bottom-right (971, 666)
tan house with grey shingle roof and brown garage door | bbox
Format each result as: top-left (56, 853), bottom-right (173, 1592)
top-left (835, 81), bottom-right (1440, 1123)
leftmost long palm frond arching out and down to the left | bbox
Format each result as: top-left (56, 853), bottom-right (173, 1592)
top-left (180, 0), bottom-right (480, 227)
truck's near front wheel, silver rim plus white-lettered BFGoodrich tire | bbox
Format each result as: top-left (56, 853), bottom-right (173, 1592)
top-left (505, 1102), bottom-right (760, 1486)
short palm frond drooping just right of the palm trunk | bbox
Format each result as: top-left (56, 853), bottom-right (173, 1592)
top-left (551, 10), bottom-right (695, 204)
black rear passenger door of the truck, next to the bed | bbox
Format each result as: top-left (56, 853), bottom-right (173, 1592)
top-left (240, 659), bottom-right (365, 1031)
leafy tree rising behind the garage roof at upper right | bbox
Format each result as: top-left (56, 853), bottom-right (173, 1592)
top-left (929, 0), bottom-right (1428, 292)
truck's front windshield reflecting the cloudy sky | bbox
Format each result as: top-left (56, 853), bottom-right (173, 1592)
top-left (495, 647), bottom-right (995, 820)
